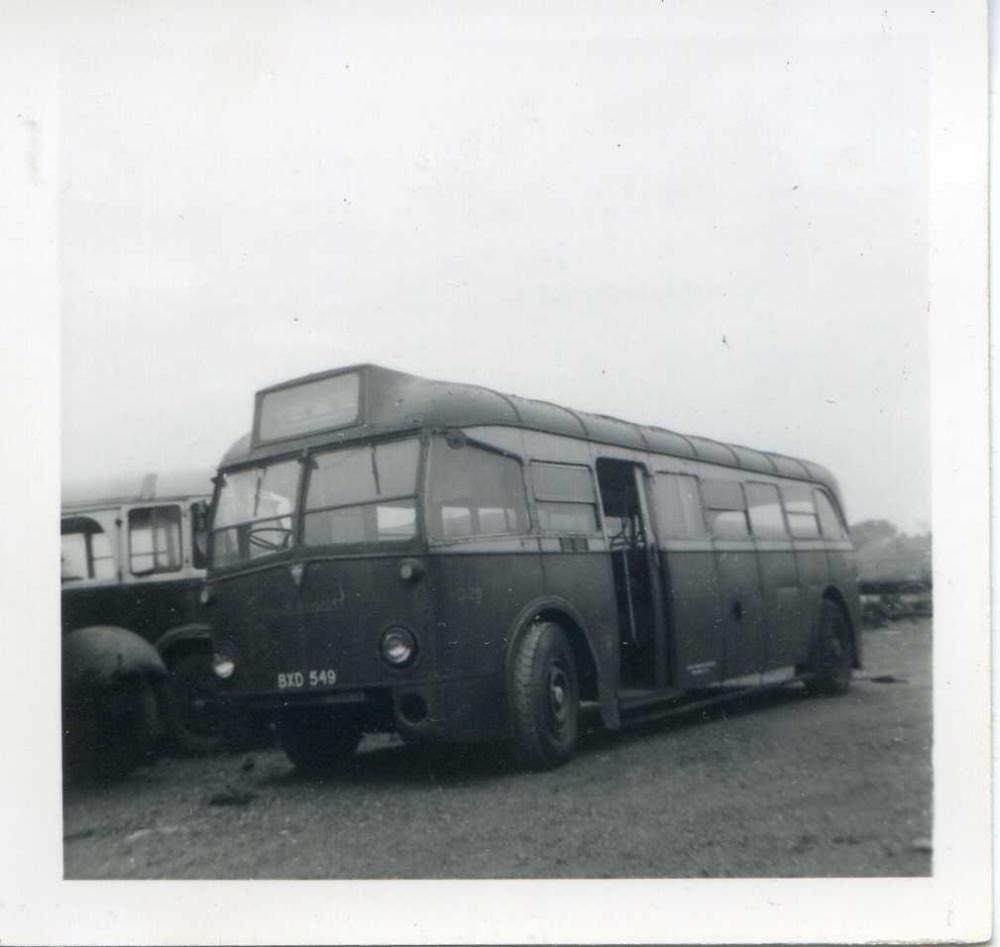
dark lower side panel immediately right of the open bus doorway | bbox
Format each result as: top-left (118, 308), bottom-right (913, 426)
top-left (660, 548), bottom-right (725, 687)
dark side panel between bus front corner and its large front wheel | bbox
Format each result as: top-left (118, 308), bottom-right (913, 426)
top-left (423, 547), bottom-right (549, 678)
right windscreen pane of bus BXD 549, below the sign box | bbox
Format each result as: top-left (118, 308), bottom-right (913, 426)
top-left (303, 438), bottom-right (420, 546)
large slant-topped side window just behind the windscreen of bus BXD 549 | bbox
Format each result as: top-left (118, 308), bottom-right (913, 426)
top-left (427, 437), bottom-right (528, 539)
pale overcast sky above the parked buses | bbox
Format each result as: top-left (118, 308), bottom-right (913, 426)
top-left (60, 2), bottom-right (930, 531)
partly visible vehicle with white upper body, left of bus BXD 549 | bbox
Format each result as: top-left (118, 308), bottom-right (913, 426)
top-left (61, 473), bottom-right (232, 775)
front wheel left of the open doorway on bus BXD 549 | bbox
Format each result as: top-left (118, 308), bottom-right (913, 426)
top-left (510, 622), bottom-right (580, 769)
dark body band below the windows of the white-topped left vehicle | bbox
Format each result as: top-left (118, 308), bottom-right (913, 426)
top-left (62, 578), bottom-right (201, 642)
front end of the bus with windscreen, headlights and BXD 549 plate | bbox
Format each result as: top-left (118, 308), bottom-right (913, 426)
top-left (204, 433), bottom-right (505, 770)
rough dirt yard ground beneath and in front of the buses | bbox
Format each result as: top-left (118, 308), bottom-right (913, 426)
top-left (64, 620), bottom-right (931, 878)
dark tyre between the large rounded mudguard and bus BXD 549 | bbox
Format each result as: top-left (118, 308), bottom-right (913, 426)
top-left (165, 651), bottom-right (228, 756)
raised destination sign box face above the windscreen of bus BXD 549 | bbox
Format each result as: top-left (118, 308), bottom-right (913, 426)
top-left (257, 372), bottom-right (361, 442)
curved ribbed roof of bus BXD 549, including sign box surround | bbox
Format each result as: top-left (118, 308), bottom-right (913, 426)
top-left (222, 364), bottom-right (840, 500)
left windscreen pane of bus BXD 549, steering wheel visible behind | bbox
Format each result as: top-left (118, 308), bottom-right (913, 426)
top-left (211, 460), bottom-right (301, 566)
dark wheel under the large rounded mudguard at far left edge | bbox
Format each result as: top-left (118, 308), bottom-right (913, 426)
top-left (63, 676), bottom-right (159, 780)
